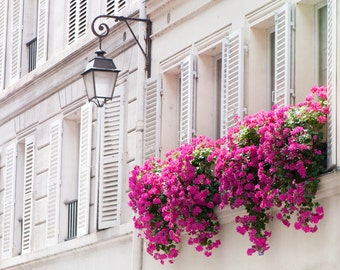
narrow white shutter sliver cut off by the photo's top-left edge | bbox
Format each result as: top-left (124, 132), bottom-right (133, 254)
top-left (0, 0), bottom-right (8, 91)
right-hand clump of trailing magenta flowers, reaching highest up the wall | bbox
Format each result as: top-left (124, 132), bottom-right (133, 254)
top-left (215, 87), bottom-right (328, 255)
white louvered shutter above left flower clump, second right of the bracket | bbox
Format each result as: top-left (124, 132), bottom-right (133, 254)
top-left (179, 55), bottom-right (196, 144)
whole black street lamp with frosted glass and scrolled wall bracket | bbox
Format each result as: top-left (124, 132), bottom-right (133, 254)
top-left (81, 15), bottom-right (151, 107)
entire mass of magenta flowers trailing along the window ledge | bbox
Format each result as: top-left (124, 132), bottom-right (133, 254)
top-left (129, 87), bottom-right (328, 263)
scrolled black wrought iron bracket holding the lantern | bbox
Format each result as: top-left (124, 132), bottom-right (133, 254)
top-left (91, 15), bottom-right (152, 78)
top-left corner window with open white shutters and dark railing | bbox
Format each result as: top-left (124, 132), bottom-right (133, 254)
top-left (0, 0), bottom-right (49, 83)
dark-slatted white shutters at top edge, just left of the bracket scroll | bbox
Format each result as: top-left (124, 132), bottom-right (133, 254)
top-left (68, 0), bottom-right (88, 44)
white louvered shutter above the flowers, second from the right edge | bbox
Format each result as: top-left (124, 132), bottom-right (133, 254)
top-left (273, 3), bottom-right (294, 107)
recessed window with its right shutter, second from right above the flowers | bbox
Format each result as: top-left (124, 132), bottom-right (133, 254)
top-left (248, 2), bottom-right (295, 113)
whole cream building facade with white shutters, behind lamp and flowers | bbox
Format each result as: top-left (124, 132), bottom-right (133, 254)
top-left (0, 0), bottom-right (340, 270)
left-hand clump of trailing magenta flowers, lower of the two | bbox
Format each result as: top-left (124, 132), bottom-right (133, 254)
top-left (129, 136), bottom-right (220, 263)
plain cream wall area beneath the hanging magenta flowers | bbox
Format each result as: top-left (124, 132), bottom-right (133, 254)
top-left (143, 175), bottom-right (340, 270)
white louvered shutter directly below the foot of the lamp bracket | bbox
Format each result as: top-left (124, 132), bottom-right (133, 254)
top-left (143, 76), bottom-right (161, 161)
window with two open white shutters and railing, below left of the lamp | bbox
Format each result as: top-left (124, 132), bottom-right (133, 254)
top-left (46, 103), bottom-right (92, 245)
